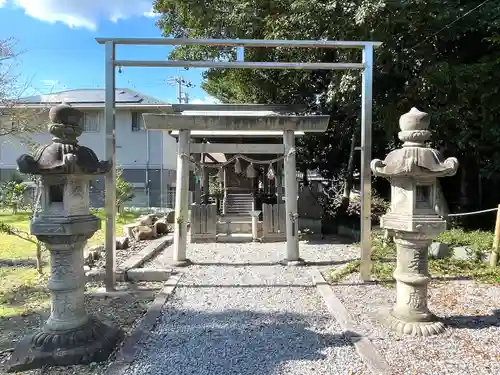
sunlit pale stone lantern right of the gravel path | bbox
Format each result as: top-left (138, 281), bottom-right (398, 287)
top-left (371, 108), bottom-right (458, 336)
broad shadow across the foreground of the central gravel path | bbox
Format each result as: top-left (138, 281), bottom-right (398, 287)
top-left (129, 307), bottom-right (351, 375)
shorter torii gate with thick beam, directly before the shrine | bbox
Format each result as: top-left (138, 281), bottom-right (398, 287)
top-left (143, 112), bottom-right (329, 266)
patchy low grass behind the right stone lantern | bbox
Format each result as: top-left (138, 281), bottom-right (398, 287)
top-left (328, 229), bottom-right (500, 287)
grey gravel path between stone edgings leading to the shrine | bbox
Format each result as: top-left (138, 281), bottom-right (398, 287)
top-left (127, 243), bottom-right (369, 375)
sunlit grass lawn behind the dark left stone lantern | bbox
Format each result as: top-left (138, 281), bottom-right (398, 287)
top-left (0, 210), bottom-right (139, 318)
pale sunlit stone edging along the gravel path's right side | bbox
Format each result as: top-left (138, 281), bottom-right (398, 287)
top-left (309, 268), bottom-right (391, 375)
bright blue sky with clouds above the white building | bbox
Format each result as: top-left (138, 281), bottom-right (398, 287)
top-left (0, 0), bottom-right (214, 103)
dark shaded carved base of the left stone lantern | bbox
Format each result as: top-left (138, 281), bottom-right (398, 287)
top-left (7, 317), bottom-right (122, 372)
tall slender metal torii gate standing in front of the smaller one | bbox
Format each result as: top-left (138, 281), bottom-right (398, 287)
top-left (96, 38), bottom-right (381, 290)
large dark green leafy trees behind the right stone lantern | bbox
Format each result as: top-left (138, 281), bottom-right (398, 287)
top-left (154, 0), bottom-right (500, 225)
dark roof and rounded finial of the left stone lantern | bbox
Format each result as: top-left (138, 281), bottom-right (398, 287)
top-left (17, 103), bottom-right (112, 175)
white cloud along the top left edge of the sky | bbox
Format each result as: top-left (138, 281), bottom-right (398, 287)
top-left (0, 0), bottom-right (156, 31)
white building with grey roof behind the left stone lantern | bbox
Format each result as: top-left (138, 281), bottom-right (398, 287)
top-left (0, 89), bottom-right (177, 207)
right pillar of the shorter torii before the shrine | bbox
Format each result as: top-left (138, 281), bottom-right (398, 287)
top-left (283, 130), bottom-right (304, 265)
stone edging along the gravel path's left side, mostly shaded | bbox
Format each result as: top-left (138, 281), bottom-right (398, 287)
top-left (104, 274), bottom-right (182, 375)
